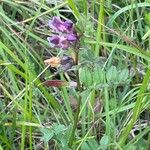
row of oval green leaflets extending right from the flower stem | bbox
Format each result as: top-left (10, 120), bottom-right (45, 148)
top-left (80, 64), bottom-right (131, 87)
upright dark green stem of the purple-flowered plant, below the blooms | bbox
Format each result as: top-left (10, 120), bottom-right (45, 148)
top-left (68, 52), bottom-right (82, 147)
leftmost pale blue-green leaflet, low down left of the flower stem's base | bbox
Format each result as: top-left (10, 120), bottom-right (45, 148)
top-left (41, 128), bottom-right (54, 142)
